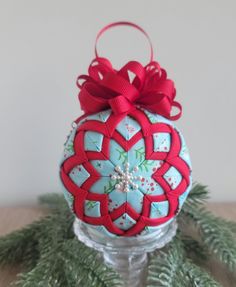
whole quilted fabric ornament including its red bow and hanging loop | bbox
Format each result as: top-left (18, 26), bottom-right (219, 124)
top-left (60, 22), bottom-right (191, 236)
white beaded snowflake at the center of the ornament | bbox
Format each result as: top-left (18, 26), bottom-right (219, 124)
top-left (111, 162), bottom-right (142, 192)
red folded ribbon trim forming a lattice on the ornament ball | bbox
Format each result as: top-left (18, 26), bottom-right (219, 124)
top-left (60, 109), bottom-right (193, 236)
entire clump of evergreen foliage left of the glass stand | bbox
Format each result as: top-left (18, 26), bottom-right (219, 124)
top-left (0, 194), bottom-right (121, 287)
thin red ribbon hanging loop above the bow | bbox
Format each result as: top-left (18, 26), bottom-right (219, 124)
top-left (94, 21), bottom-right (153, 62)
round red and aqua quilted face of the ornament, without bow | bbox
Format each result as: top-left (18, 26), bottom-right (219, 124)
top-left (60, 109), bottom-right (191, 236)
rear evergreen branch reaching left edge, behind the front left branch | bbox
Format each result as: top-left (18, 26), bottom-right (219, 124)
top-left (0, 204), bottom-right (74, 268)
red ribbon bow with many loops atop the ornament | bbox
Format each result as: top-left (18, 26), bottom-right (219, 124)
top-left (77, 57), bottom-right (182, 120)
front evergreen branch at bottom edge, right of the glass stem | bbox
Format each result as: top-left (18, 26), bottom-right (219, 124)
top-left (147, 235), bottom-right (220, 287)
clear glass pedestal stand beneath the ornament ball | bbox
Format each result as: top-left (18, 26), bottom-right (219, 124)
top-left (74, 218), bottom-right (177, 287)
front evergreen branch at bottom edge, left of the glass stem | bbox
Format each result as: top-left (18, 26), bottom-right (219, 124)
top-left (16, 238), bottom-right (122, 287)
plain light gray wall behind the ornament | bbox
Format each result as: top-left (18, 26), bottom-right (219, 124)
top-left (0, 0), bottom-right (236, 205)
